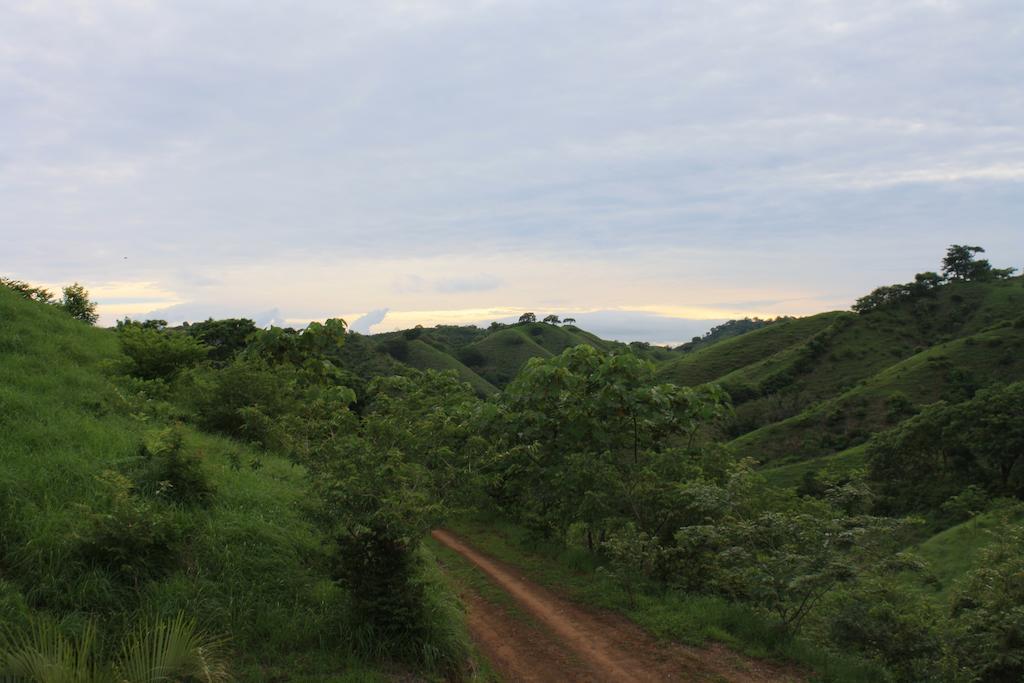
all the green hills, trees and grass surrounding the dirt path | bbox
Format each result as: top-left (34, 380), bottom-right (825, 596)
top-left (0, 245), bottom-right (1024, 682)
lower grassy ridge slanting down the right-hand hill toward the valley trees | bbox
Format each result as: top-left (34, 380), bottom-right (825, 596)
top-left (731, 318), bottom-right (1024, 462)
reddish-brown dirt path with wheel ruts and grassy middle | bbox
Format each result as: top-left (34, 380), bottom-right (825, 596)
top-left (432, 529), bottom-right (801, 683)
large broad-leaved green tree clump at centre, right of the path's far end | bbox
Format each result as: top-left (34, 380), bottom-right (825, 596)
top-left (490, 346), bottom-right (727, 536)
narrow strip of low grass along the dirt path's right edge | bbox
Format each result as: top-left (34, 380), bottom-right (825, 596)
top-left (450, 517), bottom-right (885, 683)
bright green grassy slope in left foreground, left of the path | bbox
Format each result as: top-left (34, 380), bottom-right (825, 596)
top-left (0, 288), bottom-right (393, 681)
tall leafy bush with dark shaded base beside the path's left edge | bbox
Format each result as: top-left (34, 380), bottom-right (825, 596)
top-left (303, 371), bottom-right (480, 659)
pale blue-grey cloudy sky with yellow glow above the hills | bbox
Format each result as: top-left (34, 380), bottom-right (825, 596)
top-left (0, 0), bottom-right (1024, 343)
